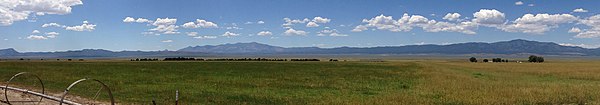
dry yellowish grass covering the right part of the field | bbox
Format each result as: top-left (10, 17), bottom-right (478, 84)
top-left (378, 61), bottom-right (600, 104)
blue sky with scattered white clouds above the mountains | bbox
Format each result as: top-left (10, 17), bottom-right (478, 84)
top-left (0, 0), bottom-right (600, 52)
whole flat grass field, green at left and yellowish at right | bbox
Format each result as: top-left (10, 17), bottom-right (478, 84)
top-left (0, 60), bottom-right (600, 104)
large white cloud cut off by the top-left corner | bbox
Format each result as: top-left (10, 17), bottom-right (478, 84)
top-left (0, 0), bottom-right (83, 26)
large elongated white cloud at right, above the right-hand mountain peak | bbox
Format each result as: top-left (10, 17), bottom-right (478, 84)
top-left (499, 14), bottom-right (578, 34)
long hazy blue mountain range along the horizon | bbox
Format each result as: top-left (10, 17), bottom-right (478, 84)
top-left (0, 39), bottom-right (600, 58)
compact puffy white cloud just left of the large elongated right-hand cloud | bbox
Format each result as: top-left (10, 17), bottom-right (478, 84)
top-left (472, 9), bottom-right (505, 26)
